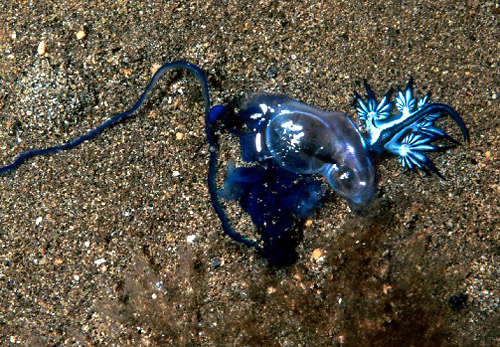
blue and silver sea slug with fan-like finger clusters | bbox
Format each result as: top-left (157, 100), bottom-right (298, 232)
top-left (355, 78), bottom-right (469, 178)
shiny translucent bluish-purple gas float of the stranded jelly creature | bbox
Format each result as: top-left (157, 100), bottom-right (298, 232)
top-left (226, 93), bottom-right (375, 210)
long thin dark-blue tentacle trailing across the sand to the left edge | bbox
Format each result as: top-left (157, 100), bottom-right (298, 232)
top-left (0, 60), bottom-right (262, 252)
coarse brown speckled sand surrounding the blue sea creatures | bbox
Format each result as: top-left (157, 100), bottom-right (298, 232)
top-left (0, 0), bottom-right (500, 346)
